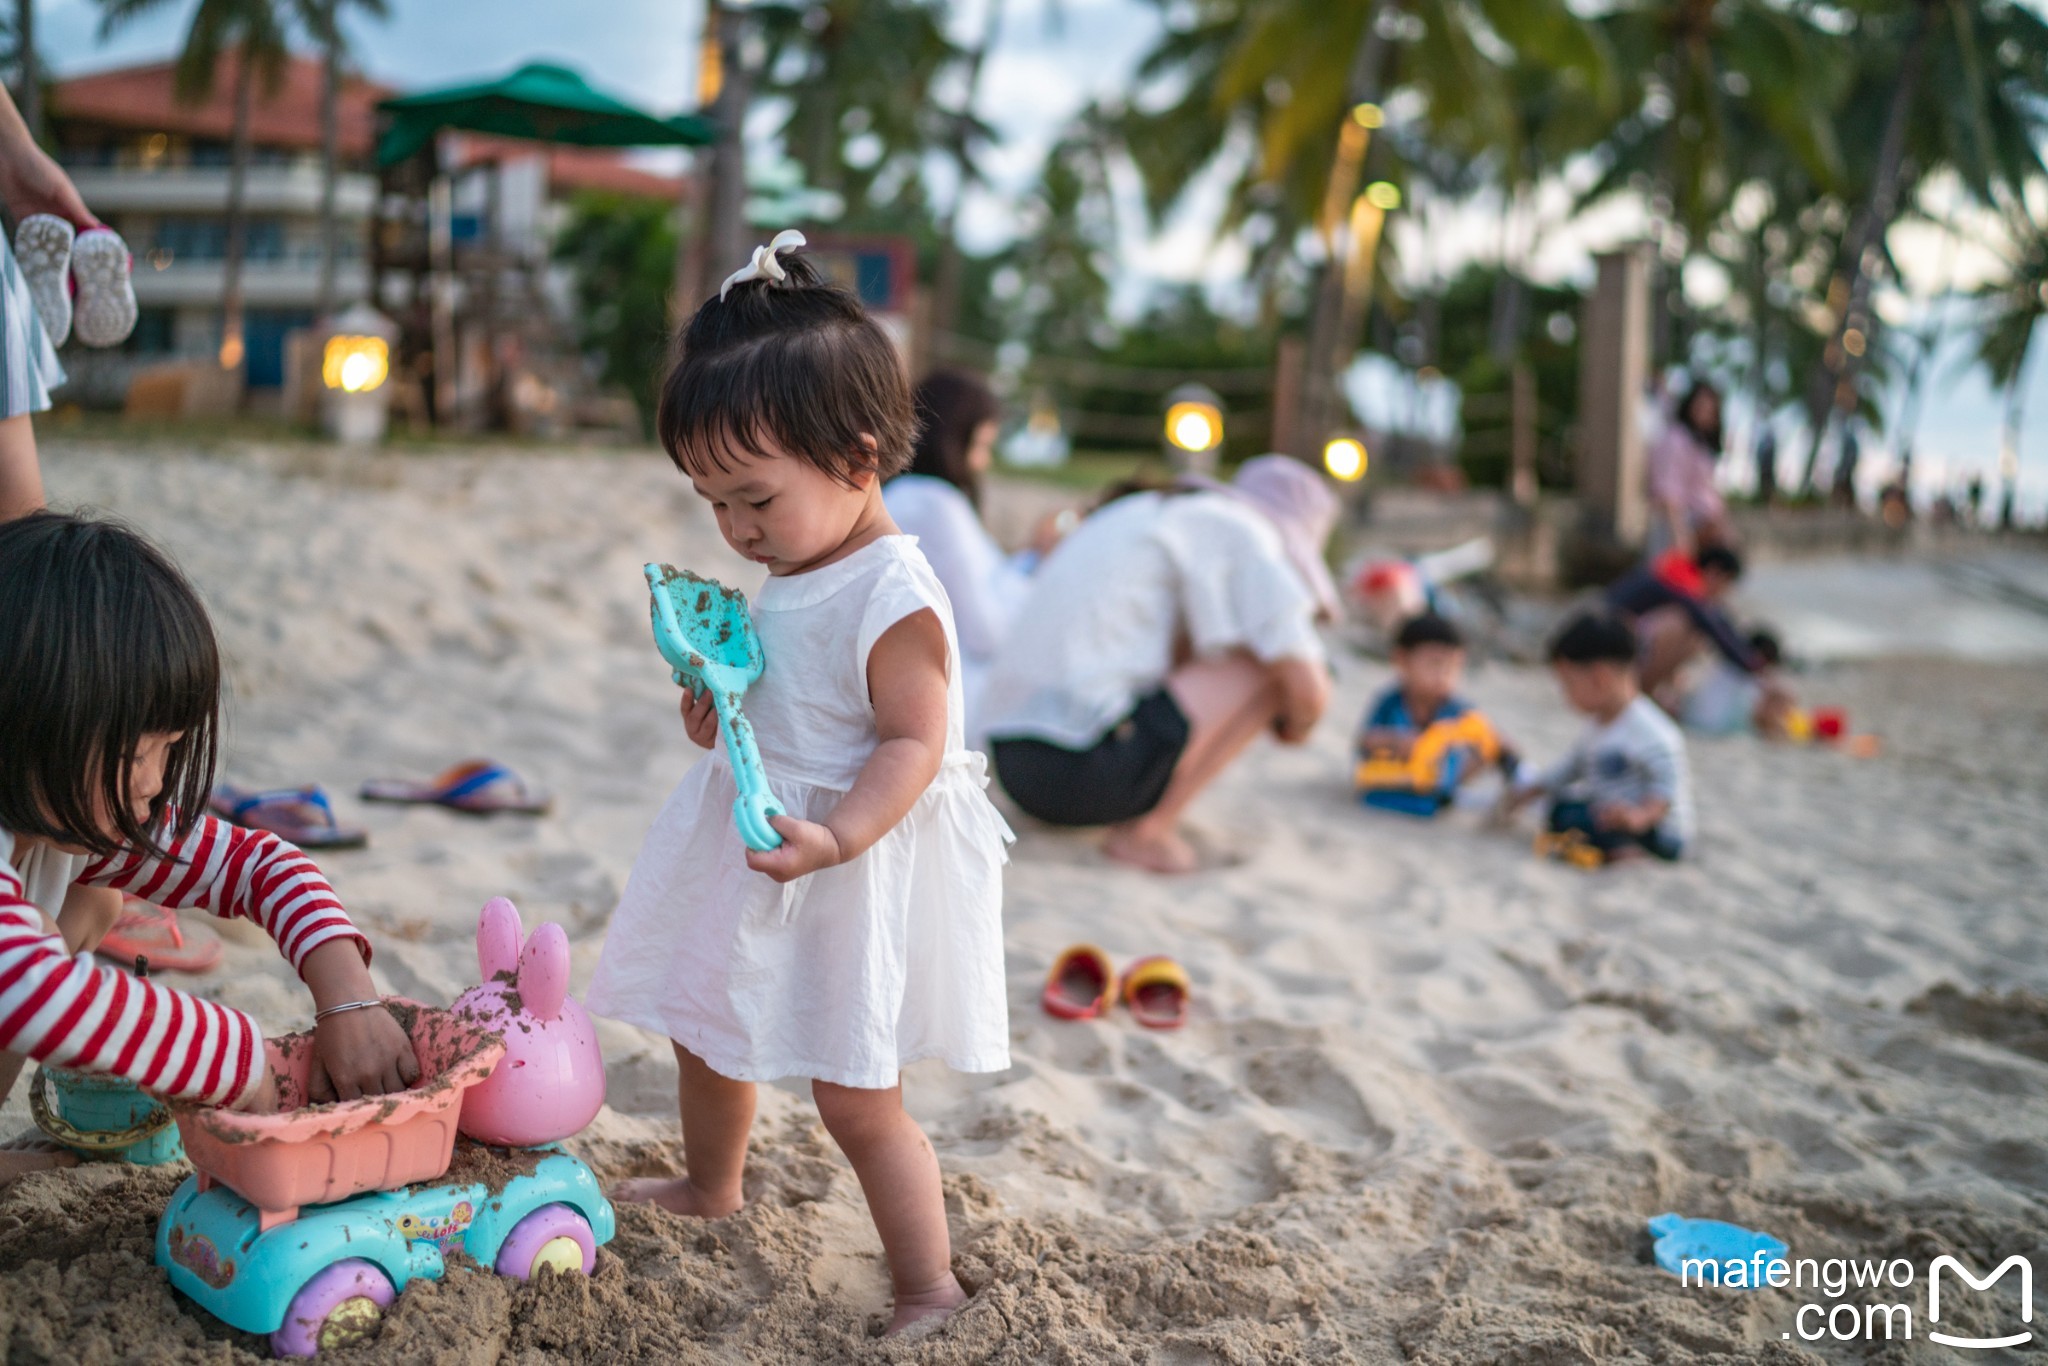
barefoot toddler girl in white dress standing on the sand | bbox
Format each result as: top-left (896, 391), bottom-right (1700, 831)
top-left (590, 233), bottom-right (1010, 1331)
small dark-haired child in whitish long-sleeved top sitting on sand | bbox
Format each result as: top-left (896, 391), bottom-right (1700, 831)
top-left (1509, 612), bottom-right (1692, 862)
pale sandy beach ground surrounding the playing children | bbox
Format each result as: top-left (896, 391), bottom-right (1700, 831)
top-left (0, 442), bottom-right (2048, 1364)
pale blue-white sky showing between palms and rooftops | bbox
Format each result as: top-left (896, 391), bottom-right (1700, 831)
top-left (37, 0), bottom-right (2048, 516)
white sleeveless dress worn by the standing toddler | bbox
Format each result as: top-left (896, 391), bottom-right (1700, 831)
top-left (590, 537), bottom-right (1014, 1087)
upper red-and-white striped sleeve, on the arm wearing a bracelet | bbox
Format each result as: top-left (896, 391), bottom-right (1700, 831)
top-left (78, 815), bottom-right (371, 971)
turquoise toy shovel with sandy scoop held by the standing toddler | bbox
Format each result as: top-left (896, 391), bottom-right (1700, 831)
top-left (645, 565), bottom-right (782, 852)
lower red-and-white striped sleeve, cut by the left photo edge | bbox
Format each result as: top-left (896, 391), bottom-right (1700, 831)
top-left (0, 862), bottom-right (266, 1104)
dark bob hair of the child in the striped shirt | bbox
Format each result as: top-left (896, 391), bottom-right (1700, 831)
top-left (0, 512), bottom-right (221, 858)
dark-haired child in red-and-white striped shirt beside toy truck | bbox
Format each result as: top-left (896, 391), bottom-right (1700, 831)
top-left (0, 512), bottom-right (420, 1182)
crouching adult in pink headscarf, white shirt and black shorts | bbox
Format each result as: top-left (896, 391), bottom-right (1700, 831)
top-left (983, 455), bottom-right (1337, 872)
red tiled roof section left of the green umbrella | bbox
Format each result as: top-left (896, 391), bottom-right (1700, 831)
top-left (49, 53), bottom-right (391, 160)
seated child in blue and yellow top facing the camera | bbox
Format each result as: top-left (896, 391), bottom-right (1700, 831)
top-left (1354, 612), bottom-right (1513, 815)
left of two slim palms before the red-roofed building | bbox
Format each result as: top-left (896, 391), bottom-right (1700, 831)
top-left (100, 0), bottom-right (291, 371)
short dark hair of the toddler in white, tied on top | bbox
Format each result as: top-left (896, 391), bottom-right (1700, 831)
top-left (655, 252), bottom-right (918, 485)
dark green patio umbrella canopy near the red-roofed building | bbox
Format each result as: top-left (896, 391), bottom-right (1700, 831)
top-left (377, 61), bottom-right (717, 166)
